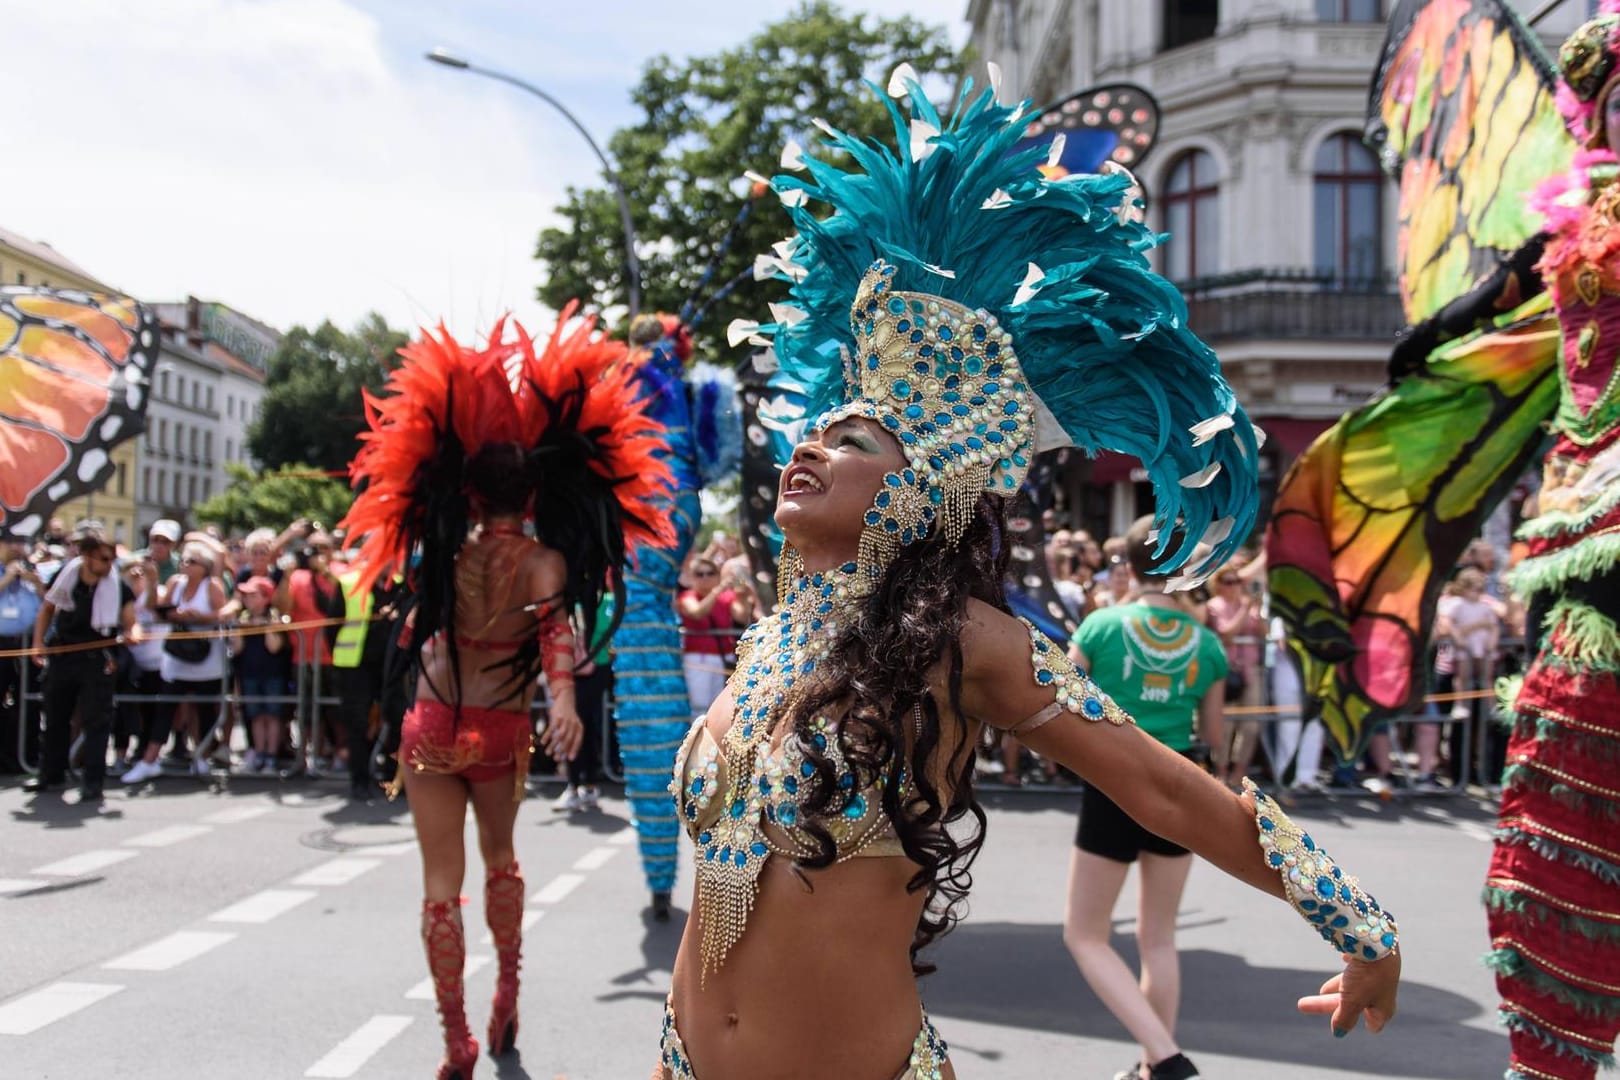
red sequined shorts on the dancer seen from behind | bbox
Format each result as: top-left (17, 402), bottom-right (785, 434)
top-left (400, 701), bottom-right (535, 800)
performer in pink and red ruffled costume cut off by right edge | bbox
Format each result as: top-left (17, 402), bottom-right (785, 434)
top-left (1486, 0), bottom-right (1620, 1080)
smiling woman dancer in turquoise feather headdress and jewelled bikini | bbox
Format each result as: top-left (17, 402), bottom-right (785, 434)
top-left (658, 68), bottom-right (1400, 1080)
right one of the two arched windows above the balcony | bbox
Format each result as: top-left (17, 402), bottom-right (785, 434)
top-left (1312, 134), bottom-right (1383, 288)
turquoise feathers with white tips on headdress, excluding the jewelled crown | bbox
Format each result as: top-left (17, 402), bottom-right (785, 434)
top-left (745, 70), bottom-right (1259, 578)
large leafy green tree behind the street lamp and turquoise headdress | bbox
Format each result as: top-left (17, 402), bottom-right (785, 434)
top-left (535, 0), bottom-right (966, 343)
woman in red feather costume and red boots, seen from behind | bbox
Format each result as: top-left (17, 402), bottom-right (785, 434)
top-left (343, 306), bottom-right (667, 1080)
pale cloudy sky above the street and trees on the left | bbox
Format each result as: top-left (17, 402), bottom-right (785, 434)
top-left (0, 0), bottom-right (966, 334)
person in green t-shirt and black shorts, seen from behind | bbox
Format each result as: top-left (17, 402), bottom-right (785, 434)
top-left (1063, 517), bottom-right (1226, 1080)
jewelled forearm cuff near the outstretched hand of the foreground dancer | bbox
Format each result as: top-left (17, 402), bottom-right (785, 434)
top-left (1243, 779), bottom-right (1400, 960)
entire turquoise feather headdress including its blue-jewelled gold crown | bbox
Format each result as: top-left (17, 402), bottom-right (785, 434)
top-left (731, 65), bottom-right (1259, 578)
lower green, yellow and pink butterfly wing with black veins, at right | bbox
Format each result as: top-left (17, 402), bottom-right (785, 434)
top-left (1265, 293), bottom-right (1558, 759)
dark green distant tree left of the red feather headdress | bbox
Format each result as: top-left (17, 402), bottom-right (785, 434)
top-left (248, 313), bottom-right (410, 473)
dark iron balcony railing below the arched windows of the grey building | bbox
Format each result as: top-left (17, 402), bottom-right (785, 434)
top-left (1181, 269), bottom-right (1406, 342)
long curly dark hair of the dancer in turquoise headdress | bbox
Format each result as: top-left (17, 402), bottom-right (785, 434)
top-left (789, 494), bottom-right (1008, 975)
